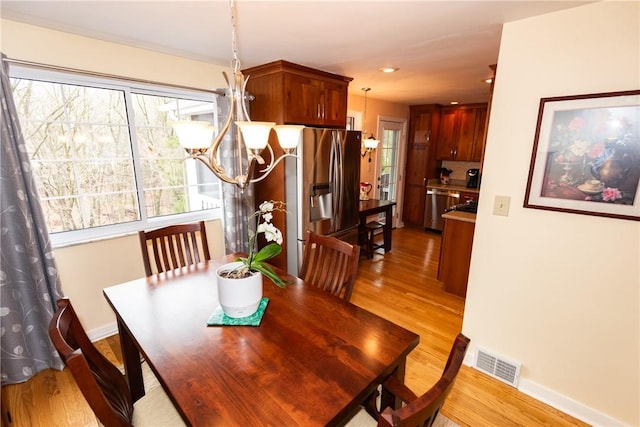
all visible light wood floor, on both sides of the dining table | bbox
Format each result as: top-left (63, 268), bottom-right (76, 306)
top-left (2, 229), bottom-right (586, 427)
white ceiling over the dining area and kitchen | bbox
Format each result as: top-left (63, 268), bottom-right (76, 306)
top-left (0, 0), bottom-right (591, 105)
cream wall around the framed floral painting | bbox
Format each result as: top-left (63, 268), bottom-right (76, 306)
top-left (463, 1), bottom-right (640, 426)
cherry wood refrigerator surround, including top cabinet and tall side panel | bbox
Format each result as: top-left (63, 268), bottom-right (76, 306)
top-left (242, 60), bottom-right (352, 270)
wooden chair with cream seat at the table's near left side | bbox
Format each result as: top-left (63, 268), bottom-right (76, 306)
top-left (49, 298), bottom-right (185, 426)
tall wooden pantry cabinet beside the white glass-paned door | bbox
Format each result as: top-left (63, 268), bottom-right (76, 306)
top-left (402, 104), bottom-right (440, 227)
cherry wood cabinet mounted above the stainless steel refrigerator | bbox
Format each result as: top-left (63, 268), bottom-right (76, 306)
top-left (242, 60), bottom-right (352, 128)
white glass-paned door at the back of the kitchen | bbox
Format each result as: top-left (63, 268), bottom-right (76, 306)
top-left (376, 118), bottom-right (406, 227)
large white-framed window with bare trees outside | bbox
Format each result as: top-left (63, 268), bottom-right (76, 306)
top-left (11, 67), bottom-right (226, 244)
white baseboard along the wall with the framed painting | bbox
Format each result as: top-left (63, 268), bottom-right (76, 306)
top-left (464, 352), bottom-right (625, 427)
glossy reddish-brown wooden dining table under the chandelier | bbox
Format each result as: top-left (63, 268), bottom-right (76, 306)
top-left (103, 255), bottom-right (419, 426)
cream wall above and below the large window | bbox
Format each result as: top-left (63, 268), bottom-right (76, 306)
top-left (1, 20), bottom-right (229, 338)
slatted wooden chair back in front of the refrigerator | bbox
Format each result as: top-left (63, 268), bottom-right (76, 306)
top-left (298, 232), bottom-right (360, 302)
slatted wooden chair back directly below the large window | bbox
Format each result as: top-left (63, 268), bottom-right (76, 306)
top-left (138, 221), bottom-right (211, 276)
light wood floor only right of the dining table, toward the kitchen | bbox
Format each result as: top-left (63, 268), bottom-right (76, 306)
top-left (351, 228), bottom-right (587, 427)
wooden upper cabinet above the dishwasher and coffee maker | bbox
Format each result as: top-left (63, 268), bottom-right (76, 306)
top-left (437, 104), bottom-right (487, 162)
